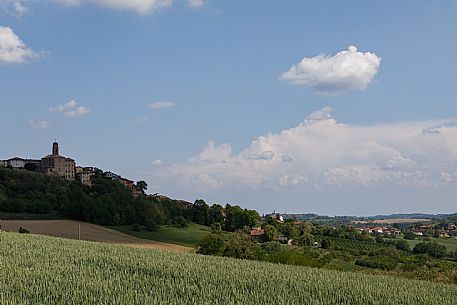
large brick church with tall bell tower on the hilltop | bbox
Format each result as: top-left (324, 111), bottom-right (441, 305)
top-left (40, 142), bottom-right (76, 180)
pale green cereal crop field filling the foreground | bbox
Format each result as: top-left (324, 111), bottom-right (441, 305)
top-left (0, 232), bottom-right (457, 305)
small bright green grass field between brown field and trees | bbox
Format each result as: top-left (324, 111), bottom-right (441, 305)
top-left (109, 223), bottom-right (220, 248)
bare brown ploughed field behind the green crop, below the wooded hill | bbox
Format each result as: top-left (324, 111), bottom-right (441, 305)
top-left (0, 220), bottom-right (192, 252)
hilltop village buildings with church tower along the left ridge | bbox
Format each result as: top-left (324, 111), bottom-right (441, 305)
top-left (0, 142), bottom-right (143, 197)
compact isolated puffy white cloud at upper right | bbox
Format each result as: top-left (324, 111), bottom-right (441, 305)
top-left (280, 46), bottom-right (381, 95)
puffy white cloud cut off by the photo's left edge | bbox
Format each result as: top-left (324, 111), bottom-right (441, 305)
top-left (0, 26), bottom-right (43, 64)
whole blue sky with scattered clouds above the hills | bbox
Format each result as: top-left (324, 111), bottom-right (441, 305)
top-left (0, 0), bottom-right (457, 215)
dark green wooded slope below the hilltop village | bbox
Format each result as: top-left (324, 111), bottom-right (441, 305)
top-left (0, 167), bottom-right (260, 232)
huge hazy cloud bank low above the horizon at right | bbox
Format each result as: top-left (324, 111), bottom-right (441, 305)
top-left (155, 108), bottom-right (457, 190)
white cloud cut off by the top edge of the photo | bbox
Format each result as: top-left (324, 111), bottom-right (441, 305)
top-left (55, 0), bottom-right (173, 14)
